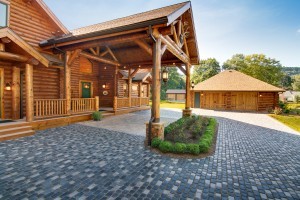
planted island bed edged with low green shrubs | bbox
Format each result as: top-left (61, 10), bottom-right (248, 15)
top-left (151, 115), bottom-right (218, 157)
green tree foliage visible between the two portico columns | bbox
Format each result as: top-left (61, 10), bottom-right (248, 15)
top-left (160, 67), bottom-right (185, 100)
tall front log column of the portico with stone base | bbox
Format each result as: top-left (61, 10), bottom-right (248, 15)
top-left (145, 34), bottom-right (164, 146)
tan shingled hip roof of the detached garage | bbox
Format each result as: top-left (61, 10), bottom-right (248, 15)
top-left (194, 70), bottom-right (284, 92)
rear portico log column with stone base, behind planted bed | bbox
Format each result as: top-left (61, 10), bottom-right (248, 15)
top-left (182, 63), bottom-right (192, 117)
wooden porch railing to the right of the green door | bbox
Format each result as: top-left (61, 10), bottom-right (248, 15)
top-left (114, 97), bottom-right (149, 110)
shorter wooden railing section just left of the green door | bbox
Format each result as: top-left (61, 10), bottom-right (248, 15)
top-left (71, 98), bottom-right (96, 113)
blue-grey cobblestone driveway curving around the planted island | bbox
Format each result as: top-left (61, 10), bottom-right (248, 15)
top-left (0, 109), bottom-right (300, 199)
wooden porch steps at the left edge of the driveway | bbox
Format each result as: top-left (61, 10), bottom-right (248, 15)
top-left (0, 122), bottom-right (35, 141)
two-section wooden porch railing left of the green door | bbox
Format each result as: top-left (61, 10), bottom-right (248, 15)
top-left (34, 97), bottom-right (99, 118)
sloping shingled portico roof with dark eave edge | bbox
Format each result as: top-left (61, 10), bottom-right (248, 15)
top-left (40, 1), bottom-right (191, 47)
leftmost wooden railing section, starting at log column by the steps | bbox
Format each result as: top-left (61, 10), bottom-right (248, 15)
top-left (34, 99), bottom-right (67, 118)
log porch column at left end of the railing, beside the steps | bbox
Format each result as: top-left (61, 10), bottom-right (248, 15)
top-left (25, 64), bottom-right (34, 122)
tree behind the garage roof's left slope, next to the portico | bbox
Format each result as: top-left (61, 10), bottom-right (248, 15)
top-left (191, 58), bottom-right (221, 84)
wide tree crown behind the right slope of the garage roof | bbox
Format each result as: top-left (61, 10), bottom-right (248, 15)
top-left (223, 54), bottom-right (284, 86)
